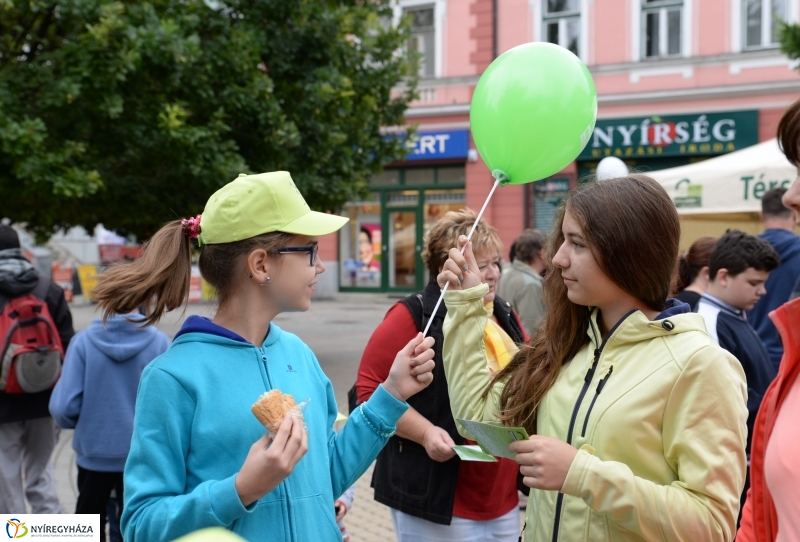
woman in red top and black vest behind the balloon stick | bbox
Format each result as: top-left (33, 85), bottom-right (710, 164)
top-left (356, 209), bottom-right (528, 542)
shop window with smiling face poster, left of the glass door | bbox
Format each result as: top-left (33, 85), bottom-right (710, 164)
top-left (339, 199), bottom-right (383, 288)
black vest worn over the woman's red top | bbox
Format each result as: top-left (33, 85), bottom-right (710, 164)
top-left (372, 282), bottom-right (523, 525)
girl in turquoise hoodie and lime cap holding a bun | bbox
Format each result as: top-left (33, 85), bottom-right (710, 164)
top-left (88, 172), bottom-right (433, 542)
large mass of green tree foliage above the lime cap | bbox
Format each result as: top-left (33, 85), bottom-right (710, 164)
top-left (0, 0), bottom-right (415, 242)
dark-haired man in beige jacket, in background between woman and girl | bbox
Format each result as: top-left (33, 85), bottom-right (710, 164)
top-left (497, 229), bottom-right (546, 337)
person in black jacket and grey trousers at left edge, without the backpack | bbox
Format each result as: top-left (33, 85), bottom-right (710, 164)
top-left (0, 224), bottom-right (75, 514)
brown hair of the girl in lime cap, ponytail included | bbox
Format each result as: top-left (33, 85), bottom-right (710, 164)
top-left (92, 220), bottom-right (294, 326)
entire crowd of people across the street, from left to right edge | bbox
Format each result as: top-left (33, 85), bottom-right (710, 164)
top-left (0, 100), bottom-right (800, 542)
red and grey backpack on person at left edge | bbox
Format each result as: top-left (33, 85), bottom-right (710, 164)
top-left (0, 278), bottom-right (64, 393)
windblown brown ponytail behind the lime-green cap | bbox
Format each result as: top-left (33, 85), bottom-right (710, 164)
top-left (92, 220), bottom-right (192, 326)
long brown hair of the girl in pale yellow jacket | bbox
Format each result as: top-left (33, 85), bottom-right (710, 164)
top-left (494, 175), bottom-right (680, 434)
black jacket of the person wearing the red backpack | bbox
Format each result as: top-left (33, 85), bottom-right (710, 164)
top-left (0, 250), bottom-right (75, 423)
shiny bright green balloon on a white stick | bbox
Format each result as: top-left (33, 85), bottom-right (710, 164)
top-left (469, 42), bottom-right (597, 184)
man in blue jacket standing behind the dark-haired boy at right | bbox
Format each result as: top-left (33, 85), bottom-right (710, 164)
top-left (747, 187), bottom-right (800, 372)
